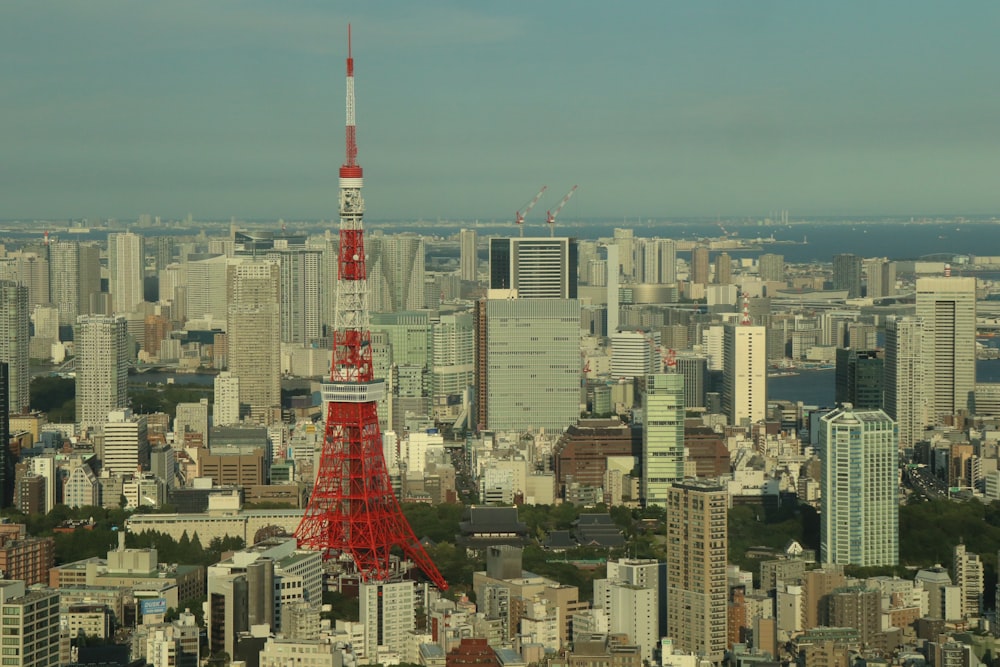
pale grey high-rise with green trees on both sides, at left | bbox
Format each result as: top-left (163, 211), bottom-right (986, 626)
top-left (74, 315), bottom-right (128, 428)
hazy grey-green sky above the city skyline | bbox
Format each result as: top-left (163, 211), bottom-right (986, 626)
top-left (0, 0), bottom-right (1000, 224)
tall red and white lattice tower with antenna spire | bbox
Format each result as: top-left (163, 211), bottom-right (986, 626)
top-left (295, 28), bottom-right (448, 590)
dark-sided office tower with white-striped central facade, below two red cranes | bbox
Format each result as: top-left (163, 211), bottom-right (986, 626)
top-left (490, 237), bottom-right (580, 299)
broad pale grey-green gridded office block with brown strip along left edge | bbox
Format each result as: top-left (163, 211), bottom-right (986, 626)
top-left (476, 299), bottom-right (580, 432)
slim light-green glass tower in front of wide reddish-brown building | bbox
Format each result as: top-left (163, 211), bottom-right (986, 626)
top-left (642, 373), bottom-right (684, 506)
